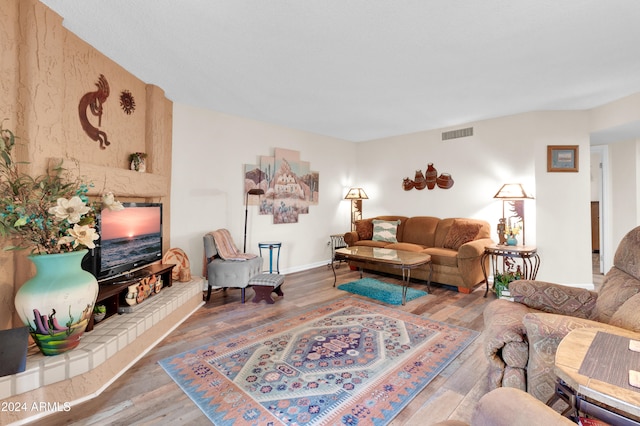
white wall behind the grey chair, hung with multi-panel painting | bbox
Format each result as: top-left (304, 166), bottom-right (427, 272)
top-left (171, 104), bottom-right (355, 275)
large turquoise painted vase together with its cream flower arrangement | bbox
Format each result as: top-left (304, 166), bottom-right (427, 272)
top-left (0, 122), bottom-right (123, 355)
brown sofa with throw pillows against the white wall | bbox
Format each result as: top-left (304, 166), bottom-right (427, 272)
top-left (344, 216), bottom-right (493, 293)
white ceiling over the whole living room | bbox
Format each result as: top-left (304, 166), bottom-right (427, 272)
top-left (41, 0), bottom-right (640, 141)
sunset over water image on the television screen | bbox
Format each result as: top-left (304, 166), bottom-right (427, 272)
top-left (100, 207), bottom-right (161, 240)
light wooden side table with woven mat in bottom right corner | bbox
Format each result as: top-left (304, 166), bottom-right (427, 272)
top-left (547, 327), bottom-right (640, 426)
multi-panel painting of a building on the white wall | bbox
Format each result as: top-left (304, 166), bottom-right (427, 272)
top-left (243, 148), bottom-right (320, 224)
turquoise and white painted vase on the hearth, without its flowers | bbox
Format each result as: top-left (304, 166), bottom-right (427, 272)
top-left (15, 250), bottom-right (99, 355)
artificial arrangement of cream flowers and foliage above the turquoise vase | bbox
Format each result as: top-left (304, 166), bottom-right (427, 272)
top-left (0, 123), bottom-right (124, 254)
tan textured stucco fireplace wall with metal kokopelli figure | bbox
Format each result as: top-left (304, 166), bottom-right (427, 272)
top-left (0, 0), bottom-right (173, 329)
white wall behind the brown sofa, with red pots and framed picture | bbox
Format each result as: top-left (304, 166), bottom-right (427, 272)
top-left (357, 112), bottom-right (592, 286)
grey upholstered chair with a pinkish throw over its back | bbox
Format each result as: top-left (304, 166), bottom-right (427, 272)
top-left (203, 230), bottom-right (262, 303)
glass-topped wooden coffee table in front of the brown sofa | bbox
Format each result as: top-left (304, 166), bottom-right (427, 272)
top-left (331, 246), bottom-right (433, 305)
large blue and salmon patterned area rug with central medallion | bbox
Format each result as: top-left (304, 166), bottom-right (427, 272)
top-left (159, 297), bottom-right (479, 425)
